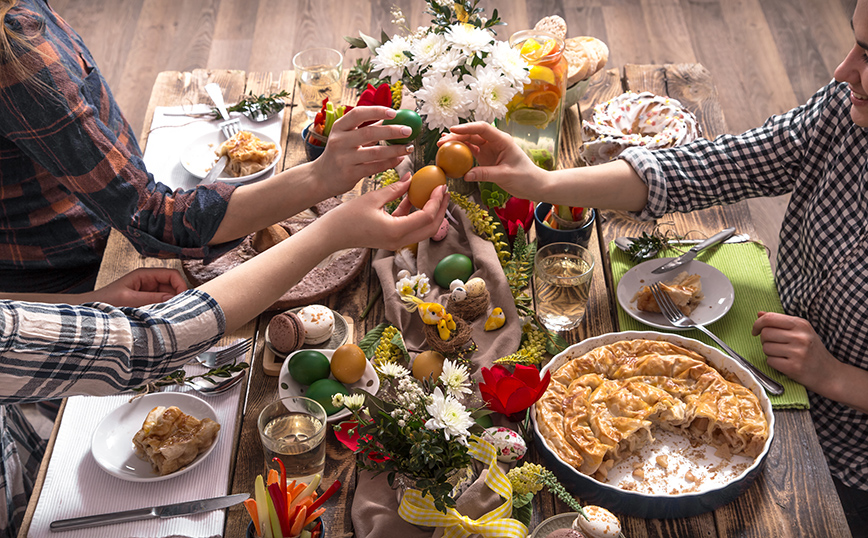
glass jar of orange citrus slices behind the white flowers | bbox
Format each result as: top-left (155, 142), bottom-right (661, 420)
top-left (482, 30), bottom-right (568, 207)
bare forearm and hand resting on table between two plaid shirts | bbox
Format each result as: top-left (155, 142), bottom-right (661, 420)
top-left (0, 267), bottom-right (187, 307)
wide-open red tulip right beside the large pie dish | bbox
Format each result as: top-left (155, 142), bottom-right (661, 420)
top-left (479, 364), bottom-right (551, 422)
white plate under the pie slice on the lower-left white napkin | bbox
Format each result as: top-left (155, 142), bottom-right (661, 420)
top-left (90, 392), bottom-right (219, 482)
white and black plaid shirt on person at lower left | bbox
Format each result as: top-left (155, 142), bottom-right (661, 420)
top-left (0, 290), bottom-right (226, 538)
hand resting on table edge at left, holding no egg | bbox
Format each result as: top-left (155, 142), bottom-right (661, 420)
top-left (84, 267), bottom-right (187, 307)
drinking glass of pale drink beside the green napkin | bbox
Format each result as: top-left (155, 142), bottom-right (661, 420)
top-left (533, 243), bottom-right (594, 331)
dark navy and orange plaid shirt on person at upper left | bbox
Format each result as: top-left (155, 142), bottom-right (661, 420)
top-left (0, 0), bottom-right (234, 292)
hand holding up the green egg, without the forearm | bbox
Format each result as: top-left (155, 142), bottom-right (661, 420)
top-left (313, 106), bottom-right (413, 196)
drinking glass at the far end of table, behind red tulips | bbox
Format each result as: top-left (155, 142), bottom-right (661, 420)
top-left (292, 48), bottom-right (344, 119)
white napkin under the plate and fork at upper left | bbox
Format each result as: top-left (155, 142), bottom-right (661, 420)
top-left (143, 104), bottom-right (284, 190)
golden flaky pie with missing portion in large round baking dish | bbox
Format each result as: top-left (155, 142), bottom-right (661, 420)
top-left (535, 340), bottom-right (769, 481)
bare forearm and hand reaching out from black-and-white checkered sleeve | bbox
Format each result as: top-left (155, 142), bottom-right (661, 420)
top-left (439, 122), bottom-right (648, 211)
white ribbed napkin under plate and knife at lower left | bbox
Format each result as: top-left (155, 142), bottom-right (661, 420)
top-left (28, 365), bottom-right (246, 538)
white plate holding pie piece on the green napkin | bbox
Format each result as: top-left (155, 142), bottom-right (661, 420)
top-left (618, 258), bottom-right (735, 331)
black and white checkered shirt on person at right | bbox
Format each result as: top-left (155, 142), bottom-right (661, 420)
top-left (621, 81), bottom-right (868, 490)
